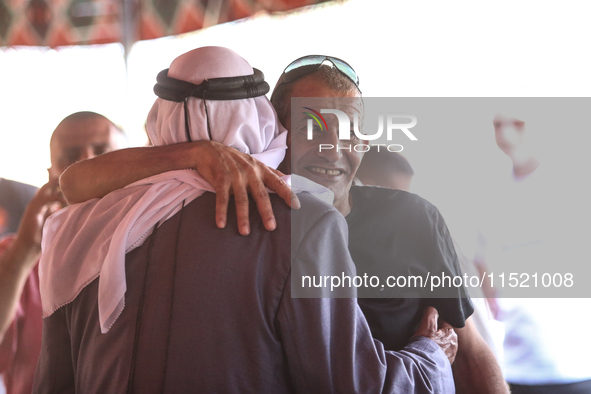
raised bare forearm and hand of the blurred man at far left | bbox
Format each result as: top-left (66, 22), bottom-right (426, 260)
top-left (0, 182), bottom-right (63, 342)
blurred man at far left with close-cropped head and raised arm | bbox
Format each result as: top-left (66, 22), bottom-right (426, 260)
top-left (0, 112), bottom-right (126, 394)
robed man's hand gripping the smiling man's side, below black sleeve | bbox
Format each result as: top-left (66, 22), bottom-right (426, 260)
top-left (413, 306), bottom-right (458, 364)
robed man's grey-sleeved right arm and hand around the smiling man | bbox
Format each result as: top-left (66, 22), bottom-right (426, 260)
top-left (284, 202), bottom-right (457, 393)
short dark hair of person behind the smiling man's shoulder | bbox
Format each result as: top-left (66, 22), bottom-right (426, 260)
top-left (357, 146), bottom-right (415, 178)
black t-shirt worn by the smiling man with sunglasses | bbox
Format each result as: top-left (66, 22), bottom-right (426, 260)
top-left (346, 186), bottom-right (474, 350)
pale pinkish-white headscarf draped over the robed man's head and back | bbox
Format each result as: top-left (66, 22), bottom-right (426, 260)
top-left (39, 47), bottom-right (287, 333)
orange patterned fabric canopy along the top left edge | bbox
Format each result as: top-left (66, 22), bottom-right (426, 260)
top-left (0, 0), bottom-right (327, 47)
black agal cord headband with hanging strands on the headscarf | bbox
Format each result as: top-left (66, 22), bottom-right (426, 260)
top-left (154, 68), bottom-right (269, 142)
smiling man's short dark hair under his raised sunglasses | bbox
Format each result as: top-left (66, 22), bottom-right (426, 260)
top-left (271, 64), bottom-right (359, 127)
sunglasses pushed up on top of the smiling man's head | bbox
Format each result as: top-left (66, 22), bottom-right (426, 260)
top-left (277, 55), bottom-right (361, 92)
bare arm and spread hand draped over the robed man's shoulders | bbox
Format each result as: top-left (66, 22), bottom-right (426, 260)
top-left (60, 141), bottom-right (299, 235)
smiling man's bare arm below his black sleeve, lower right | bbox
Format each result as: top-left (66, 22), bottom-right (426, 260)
top-left (452, 318), bottom-right (509, 394)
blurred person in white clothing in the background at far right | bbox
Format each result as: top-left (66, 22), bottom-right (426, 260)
top-left (474, 115), bottom-right (591, 394)
